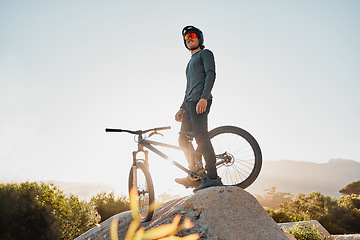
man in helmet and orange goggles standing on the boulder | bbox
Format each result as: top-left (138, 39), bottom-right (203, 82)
top-left (175, 26), bottom-right (223, 192)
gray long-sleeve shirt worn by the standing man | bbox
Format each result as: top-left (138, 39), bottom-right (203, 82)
top-left (181, 49), bottom-right (216, 109)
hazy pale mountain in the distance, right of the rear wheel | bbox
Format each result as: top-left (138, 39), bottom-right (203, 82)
top-left (246, 159), bottom-right (360, 197)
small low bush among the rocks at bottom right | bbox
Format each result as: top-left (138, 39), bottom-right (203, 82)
top-left (285, 222), bottom-right (326, 240)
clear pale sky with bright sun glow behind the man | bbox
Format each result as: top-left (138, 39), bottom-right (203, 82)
top-left (0, 0), bottom-right (360, 197)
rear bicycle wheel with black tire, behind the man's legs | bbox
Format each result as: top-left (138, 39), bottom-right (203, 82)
top-left (209, 126), bottom-right (262, 189)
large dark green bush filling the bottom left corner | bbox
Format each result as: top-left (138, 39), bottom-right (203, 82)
top-left (0, 182), bottom-right (98, 240)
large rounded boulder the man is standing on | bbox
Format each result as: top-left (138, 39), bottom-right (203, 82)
top-left (77, 187), bottom-right (289, 240)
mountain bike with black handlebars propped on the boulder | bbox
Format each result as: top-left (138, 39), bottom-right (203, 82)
top-left (105, 126), bottom-right (262, 222)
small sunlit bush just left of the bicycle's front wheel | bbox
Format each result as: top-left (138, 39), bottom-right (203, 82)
top-left (90, 192), bottom-right (130, 222)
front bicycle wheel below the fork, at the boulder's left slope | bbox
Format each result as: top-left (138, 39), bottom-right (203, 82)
top-left (129, 161), bottom-right (155, 222)
